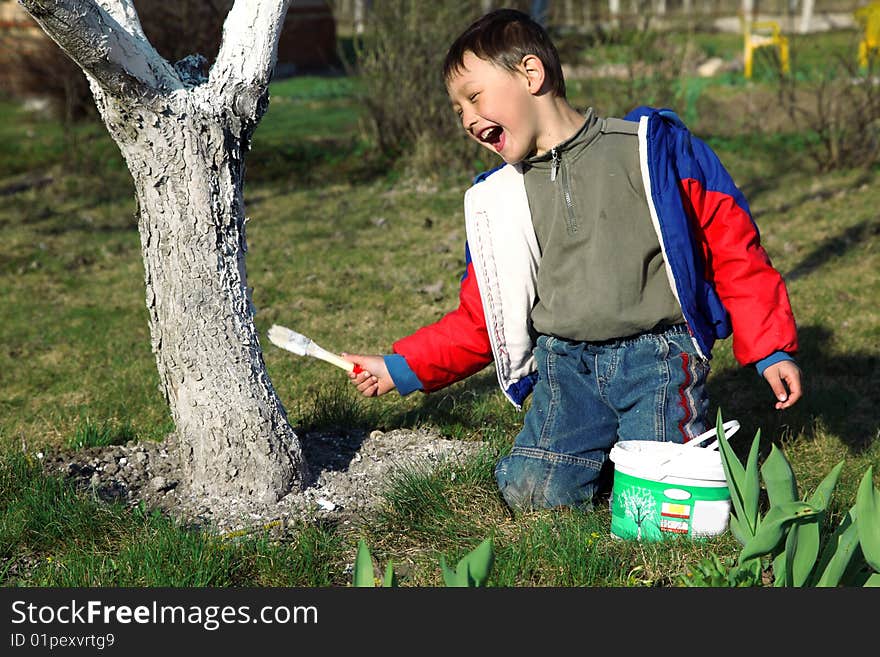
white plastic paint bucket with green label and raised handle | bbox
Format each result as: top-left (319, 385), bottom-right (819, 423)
top-left (609, 420), bottom-right (739, 541)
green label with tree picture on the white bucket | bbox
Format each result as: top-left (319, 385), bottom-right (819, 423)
top-left (611, 470), bottom-right (730, 541)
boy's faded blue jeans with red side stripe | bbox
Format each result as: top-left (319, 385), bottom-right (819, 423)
top-left (495, 324), bottom-right (709, 510)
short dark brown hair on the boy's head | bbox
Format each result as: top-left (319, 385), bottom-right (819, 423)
top-left (443, 9), bottom-right (565, 98)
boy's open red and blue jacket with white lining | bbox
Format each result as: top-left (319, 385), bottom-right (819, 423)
top-left (385, 107), bottom-right (798, 407)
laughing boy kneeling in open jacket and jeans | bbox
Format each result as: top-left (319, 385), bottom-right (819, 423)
top-left (347, 10), bottom-right (801, 509)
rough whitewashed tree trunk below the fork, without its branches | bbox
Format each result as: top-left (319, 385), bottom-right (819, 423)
top-left (120, 94), bottom-right (302, 499)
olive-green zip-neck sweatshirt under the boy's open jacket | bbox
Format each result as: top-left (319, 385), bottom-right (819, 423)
top-left (523, 109), bottom-right (684, 341)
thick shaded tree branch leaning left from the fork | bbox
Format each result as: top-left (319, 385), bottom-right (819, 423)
top-left (19, 0), bottom-right (182, 96)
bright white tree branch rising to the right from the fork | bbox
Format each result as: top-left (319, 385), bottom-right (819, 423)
top-left (209, 0), bottom-right (290, 118)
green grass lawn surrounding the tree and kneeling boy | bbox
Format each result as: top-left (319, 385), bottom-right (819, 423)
top-left (0, 25), bottom-right (880, 587)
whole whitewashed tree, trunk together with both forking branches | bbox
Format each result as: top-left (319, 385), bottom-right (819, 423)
top-left (19, 0), bottom-right (307, 501)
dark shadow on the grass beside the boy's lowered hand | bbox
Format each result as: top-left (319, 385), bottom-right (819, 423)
top-left (708, 326), bottom-right (880, 454)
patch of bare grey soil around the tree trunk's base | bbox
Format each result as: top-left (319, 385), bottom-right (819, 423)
top-left (43, 429), bottom-right (482, 533)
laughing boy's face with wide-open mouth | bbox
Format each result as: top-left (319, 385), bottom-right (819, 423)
top-left (447, 52), bottom-right (538, 164)
